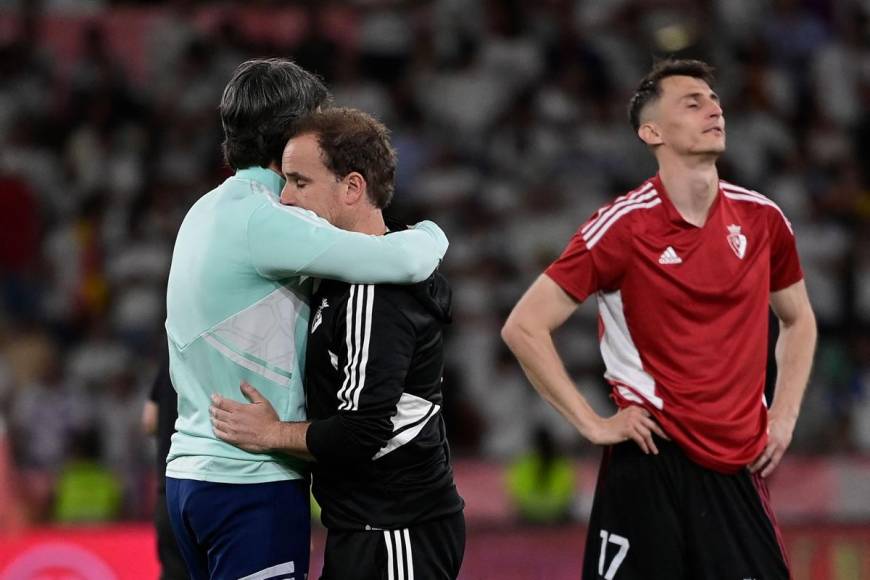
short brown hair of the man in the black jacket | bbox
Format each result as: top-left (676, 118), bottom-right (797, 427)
top-left (293, 107), bottom-right (396, 209)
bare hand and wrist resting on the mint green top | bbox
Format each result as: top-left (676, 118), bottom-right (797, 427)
top-left (211, 383), bottom-right (314, 461)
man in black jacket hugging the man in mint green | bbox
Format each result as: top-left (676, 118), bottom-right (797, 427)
top-left (212, 109), bottom-right (465, 580)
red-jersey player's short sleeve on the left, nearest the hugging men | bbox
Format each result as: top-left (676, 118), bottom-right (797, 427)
top-left (544, 212), bottom-right (631, 302)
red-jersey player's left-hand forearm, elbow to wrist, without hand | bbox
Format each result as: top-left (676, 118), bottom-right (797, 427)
top-left (502, 321), bottom-right (601, 439)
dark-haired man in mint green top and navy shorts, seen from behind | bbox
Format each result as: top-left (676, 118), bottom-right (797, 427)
top-left (166, 59), bottom-right (447, 580)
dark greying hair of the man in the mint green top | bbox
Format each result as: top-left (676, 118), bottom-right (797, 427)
top-left (220, 58), bottom-right (331, 169)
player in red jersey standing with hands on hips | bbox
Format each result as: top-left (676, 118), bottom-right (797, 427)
top-left (502, 60), bottom-right (816, 580)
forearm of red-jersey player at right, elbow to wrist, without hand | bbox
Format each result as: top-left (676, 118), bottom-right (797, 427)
top-left (771, 316), bottom-right (816, 421)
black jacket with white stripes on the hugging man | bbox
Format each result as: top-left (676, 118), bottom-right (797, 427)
top-left (305, 273), bottom-right (463, 529)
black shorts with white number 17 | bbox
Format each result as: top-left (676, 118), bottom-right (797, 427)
top-left (583, 438), bottom-right (789, 580)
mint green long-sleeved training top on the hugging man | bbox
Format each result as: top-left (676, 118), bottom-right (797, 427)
top-left (166, 167), bottom-right (447, 483)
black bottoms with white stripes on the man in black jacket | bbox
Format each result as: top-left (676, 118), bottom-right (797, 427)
top-left (320, 511), bottom-right (465, 580)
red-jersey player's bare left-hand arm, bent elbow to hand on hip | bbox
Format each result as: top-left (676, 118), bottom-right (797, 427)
top-left (501, 275), bottom-right (665, 453)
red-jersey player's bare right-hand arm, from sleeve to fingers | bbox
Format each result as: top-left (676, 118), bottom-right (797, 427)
top-left (749, 280), bottom-right (816, 477)
